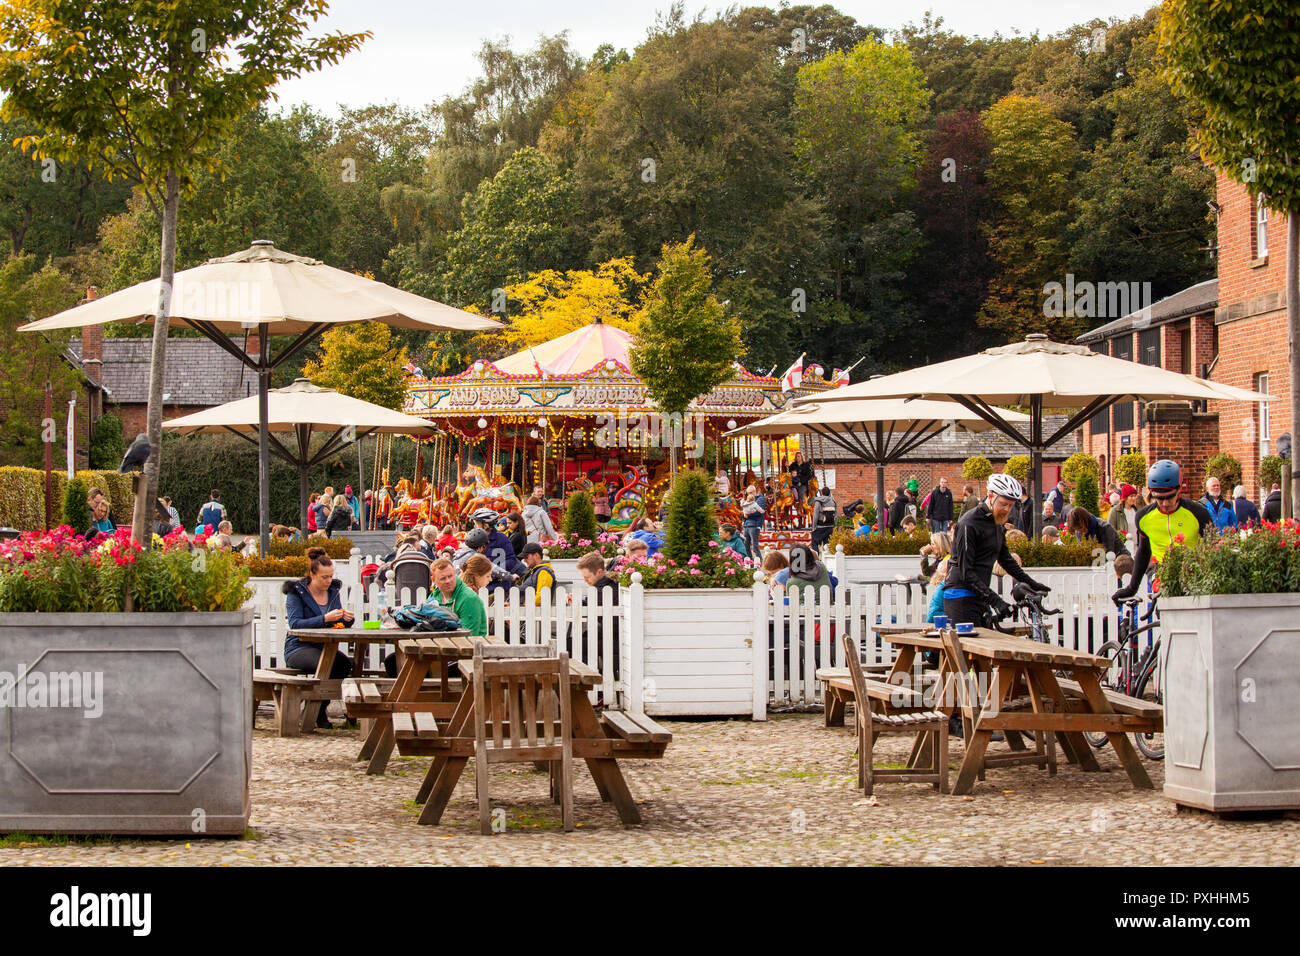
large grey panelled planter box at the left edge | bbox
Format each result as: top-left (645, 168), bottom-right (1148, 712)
top-left (0, 609), bottom-right (252, 835)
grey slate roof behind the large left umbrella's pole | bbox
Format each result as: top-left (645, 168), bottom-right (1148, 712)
top-left (69, 338), bottom-right (257, 407)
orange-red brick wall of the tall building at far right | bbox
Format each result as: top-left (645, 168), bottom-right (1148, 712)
top-left (1210, 176), bottom-right (1291, 499)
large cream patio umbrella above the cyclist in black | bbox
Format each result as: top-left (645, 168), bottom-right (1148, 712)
top-left (794, 334), bottom-right (1269, 536)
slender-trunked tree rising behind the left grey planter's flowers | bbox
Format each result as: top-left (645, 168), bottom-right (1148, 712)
top-left (0, 0), bottom-right (369, 541)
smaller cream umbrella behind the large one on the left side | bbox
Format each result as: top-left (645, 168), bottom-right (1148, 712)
top-left (163, 378), bottom-right (438, 532)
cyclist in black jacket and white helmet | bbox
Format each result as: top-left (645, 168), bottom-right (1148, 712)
top-left (944, 475), bottom-right (1050, 624)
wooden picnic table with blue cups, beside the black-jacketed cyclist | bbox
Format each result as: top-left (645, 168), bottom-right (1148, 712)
top-left (884, 628), bottom-right (1161, 793)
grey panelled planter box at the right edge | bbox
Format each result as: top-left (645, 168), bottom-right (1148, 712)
top-left (1160, 593), bottom-right (1300, 810)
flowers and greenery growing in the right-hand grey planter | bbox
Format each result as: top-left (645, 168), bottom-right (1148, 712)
top-left (1157, 519), bottom-right (1300, 597)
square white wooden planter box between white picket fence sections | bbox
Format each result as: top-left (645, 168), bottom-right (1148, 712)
top-left (627, 588), bottom-right (767, 717)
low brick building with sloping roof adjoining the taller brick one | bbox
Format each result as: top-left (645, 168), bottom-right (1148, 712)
top-left (1076, 278), bottom-right (1219, 494)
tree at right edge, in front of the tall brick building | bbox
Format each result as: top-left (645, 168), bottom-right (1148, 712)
top-left (1160, 0), bottom-right (1300, 514)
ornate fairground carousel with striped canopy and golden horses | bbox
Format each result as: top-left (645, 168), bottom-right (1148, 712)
top-left (378, 321), bottom-right (829, 528)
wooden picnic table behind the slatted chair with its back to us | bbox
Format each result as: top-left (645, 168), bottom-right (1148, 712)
top-left (394, 658), bottom-right (672, 825)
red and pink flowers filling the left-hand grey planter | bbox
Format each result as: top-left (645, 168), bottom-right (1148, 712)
top-left (0, 525), bottom-right (251, 614)
